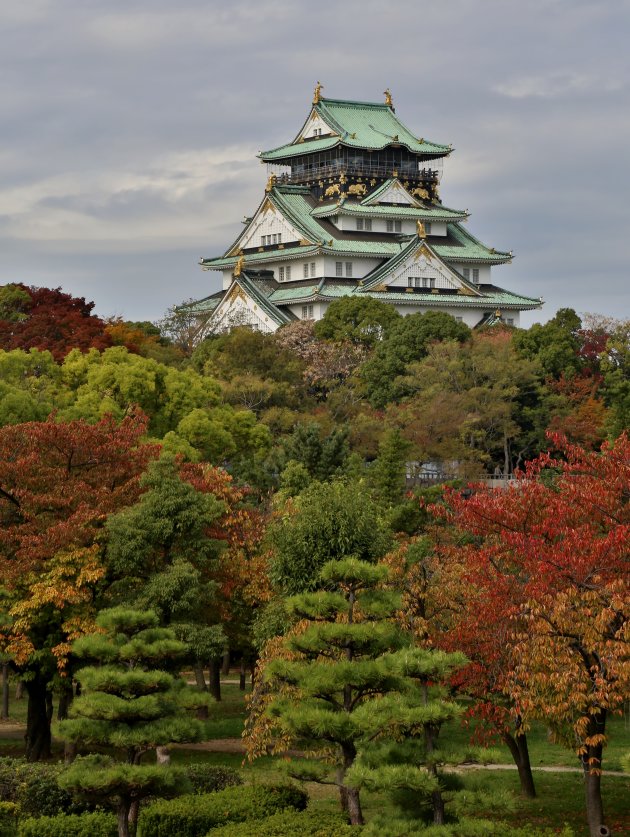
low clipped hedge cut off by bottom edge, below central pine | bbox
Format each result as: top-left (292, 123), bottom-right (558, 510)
top-left (207, 811), bottom-right (363, 837)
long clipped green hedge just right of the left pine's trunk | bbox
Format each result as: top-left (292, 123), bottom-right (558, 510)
top-left (139, 785), bottom-right (308, 837)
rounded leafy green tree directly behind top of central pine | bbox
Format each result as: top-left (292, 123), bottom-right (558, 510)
top-left (270, 482), bottom-right (391, 595)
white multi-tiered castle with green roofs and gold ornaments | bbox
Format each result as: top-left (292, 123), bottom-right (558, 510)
top-left (192, 83), bottom-right (542, 333)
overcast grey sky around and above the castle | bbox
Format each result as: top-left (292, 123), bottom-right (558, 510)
top-left (0, 0), bottom-right (630, 325)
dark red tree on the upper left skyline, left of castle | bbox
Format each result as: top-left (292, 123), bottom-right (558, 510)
top-left (0, 284), bottom-right (111, 360)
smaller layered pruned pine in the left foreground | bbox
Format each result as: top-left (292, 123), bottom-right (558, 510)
top-left (58, 607), bottom-right (209, 837)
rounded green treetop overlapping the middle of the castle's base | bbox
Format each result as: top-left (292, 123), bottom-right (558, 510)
top-left (314, 296), bottom-right (401, 348)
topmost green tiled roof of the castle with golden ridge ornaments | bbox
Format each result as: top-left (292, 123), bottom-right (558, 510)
top-left (259, 91), bottom-right (452, 163)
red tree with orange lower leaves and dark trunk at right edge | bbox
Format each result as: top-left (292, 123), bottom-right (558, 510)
top-left (450, 434), bottom-right (630, 837)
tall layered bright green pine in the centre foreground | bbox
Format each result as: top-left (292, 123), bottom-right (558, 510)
top-left (264, 558), bottom-right (405, 825)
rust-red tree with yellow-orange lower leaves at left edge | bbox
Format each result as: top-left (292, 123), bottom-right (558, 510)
top-left (0, 415), bottom-right (156, 760)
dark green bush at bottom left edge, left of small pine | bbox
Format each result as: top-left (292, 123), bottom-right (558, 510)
top-left (0, 758), bottom-right (89, 817)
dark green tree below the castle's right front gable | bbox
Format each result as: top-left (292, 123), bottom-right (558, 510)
top-left (360, 311), bottom-right (470, 407)
